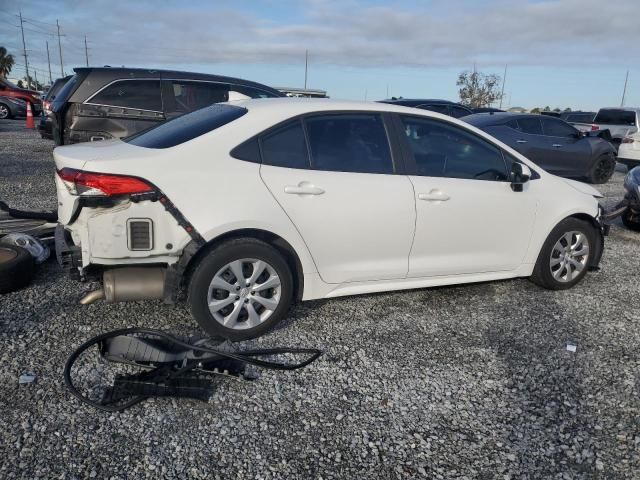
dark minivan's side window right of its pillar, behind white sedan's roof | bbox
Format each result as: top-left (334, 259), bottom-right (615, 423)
top-left (165, 81), bottom-right (229, 113)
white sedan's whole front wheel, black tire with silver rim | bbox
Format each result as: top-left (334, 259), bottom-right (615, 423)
top-left (530, 218), bottom-right (596, 290)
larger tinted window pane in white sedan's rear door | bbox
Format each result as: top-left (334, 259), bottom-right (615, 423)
top-left (305, 113), bottom-right (393, 173)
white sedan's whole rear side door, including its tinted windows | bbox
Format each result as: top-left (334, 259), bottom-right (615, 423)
top-left (260, 112), bottom-right (415, 284)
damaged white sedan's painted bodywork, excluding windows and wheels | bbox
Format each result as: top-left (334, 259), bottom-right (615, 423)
top-left (54, 98), bottom-right (599, 300)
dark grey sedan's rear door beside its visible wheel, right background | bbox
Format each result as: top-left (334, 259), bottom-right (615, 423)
top-left (541, 117), bottom-right (591, 176)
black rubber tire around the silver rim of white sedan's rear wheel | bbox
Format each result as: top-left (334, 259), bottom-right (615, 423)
top-left (188, 238), bottom-right (293, 341)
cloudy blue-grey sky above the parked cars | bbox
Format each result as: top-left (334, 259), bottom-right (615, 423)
top-left (0, 0), bottom-right (640, 108)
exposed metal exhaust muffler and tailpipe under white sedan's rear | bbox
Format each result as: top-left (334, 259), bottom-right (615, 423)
top-left (80, 267), bottom-right (166, 305)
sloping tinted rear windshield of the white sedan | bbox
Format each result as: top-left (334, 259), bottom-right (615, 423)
top-left (122, 104), bottom-right (247, 148)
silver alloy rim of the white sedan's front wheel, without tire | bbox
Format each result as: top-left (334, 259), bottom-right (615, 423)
top-left (549, 231), bottom-right (589, 283)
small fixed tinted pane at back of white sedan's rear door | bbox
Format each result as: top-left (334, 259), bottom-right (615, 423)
top-left (260, 120), bottom-right (309, 168)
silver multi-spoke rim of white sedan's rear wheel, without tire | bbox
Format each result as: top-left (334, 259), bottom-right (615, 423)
top-left (207, 258), bottom-right (281, 330)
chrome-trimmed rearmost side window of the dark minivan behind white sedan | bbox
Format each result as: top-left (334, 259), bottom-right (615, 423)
top-left (87, 80), bottom-right (162, 112)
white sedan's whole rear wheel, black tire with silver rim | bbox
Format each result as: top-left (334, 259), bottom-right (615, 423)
top-left (188, 238), bottom-right (294, 341)
